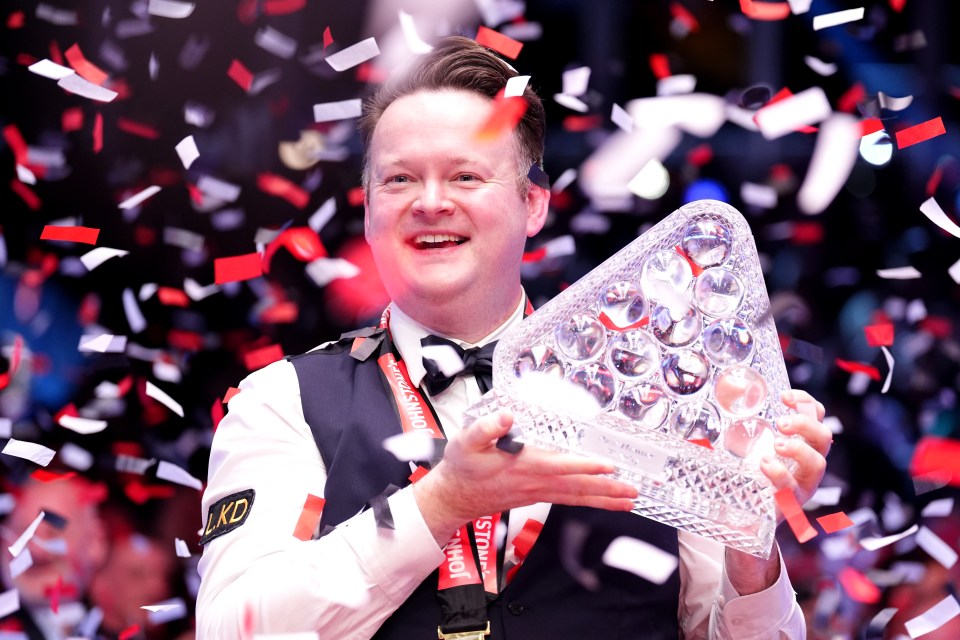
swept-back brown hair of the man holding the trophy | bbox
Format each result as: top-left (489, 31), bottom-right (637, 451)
top-left (357, 36), bottom-right (546, 193)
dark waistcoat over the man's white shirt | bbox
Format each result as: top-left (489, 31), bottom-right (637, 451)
top-left (289, 340), bottom-right (680, 640)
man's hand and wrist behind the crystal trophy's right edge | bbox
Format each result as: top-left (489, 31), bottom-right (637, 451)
top-left (724, 389), bottom-right (833, 595)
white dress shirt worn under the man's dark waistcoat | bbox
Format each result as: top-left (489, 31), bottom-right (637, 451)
top-left (197, 304), bottom-right (805, 640)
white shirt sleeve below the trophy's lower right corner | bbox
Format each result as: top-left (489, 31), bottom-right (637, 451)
top-left (679, 531), bottom-right (806, 640)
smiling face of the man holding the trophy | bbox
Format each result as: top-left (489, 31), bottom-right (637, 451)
top-left (365, 90), bottom-right (547, 312)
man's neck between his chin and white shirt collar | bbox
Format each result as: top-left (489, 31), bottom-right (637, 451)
top-left (394, 289), bottom-right (523, 344)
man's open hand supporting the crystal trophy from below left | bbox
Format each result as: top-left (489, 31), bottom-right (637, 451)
top-left (413, 411), bottom-right (637, 546)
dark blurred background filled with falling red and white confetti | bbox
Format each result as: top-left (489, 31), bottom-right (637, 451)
top-left (0, 0), bottom-right (960, 639)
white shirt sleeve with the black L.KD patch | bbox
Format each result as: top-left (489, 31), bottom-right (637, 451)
top-left (197, 361), bottom-right (443, 640)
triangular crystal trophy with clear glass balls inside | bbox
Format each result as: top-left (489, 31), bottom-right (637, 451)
top-left (467, 200), bottom-right (792, 558)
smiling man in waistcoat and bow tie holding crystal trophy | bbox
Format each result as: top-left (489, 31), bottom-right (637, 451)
top-left (197, 37), bottom-right (830, 640)
